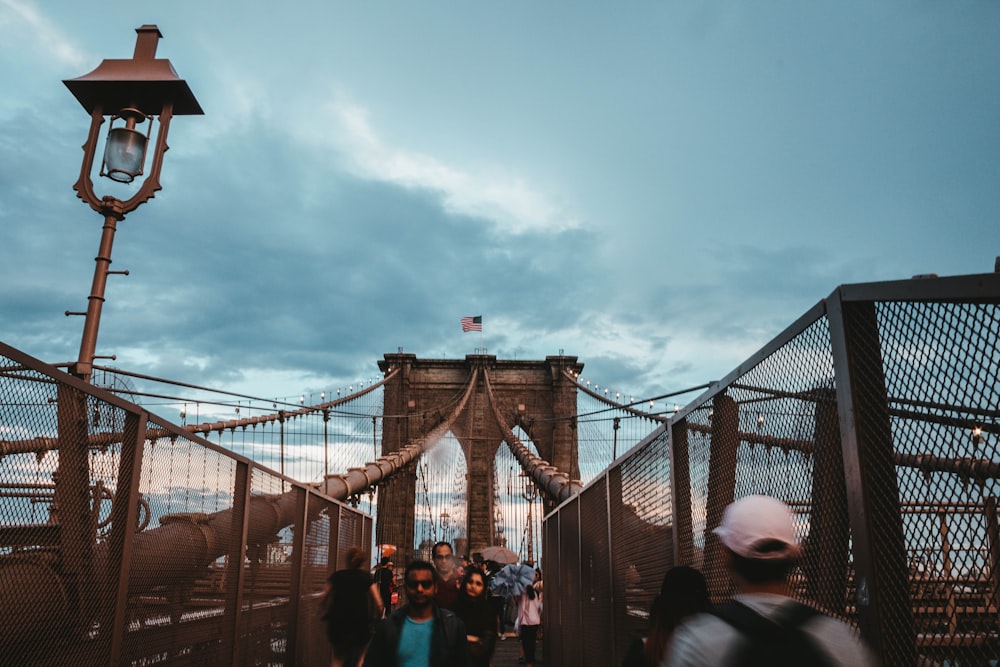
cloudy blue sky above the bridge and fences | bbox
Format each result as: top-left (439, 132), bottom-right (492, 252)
top-left (0, 0), bottom-right (1000, 412)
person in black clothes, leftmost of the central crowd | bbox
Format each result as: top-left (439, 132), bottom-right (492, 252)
top-left (322, 547), bottom-right (382, 667)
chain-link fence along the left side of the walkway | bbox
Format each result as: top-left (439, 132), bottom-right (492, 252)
top-left (0, 343), bottom-right (372, 665)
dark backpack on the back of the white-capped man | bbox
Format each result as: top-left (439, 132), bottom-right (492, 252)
top-left (710, 600), bottom-right (832, 667)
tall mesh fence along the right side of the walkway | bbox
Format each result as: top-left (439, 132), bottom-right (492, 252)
top-left (543, 274), bottom-right (1000, 665)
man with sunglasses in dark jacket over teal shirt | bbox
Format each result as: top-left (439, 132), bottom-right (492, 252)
top-left (365, 560), bottom-right (468, 667)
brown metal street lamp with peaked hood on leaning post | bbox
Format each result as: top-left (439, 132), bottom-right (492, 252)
top-left (63, 25), bottom-right (203, 381)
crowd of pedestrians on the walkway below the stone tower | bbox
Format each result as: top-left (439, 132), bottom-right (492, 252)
top-left (323, 542), bottom-right (542, 667)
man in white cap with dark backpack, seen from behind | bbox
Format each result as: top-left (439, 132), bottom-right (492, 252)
top-left (663, 496), bottom-right (877, 667)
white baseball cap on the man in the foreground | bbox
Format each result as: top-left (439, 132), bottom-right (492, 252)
top-left (712, 496), bottom-right (801, 560)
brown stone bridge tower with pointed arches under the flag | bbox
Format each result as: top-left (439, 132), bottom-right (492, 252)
top-left (375, 353), bottom-right (583, 562)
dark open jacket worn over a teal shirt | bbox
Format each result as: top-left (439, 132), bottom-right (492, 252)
top-left (365, 606), bottom-right (469, 667)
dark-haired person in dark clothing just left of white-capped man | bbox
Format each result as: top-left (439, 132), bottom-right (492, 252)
top-left (622, 565), bottom-right (709, 667)
